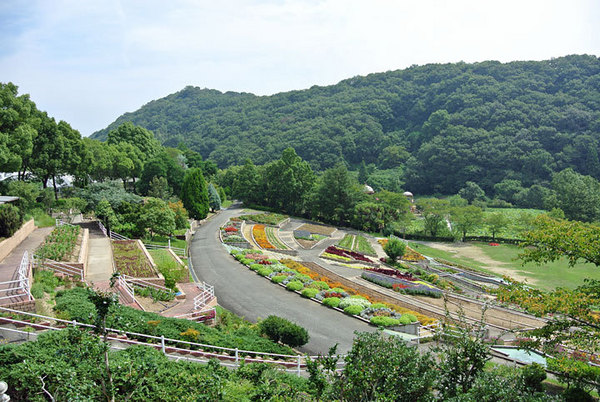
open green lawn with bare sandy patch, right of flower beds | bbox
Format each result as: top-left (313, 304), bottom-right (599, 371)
top-left (410, 243), bottom-right (600, 290)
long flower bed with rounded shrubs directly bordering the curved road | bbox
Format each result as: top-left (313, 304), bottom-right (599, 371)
top-left (230, 248), bottom-right (432, 327)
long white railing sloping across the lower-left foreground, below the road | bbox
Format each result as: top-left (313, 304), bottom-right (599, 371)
top-left (0, 306), bottom-right (345, 376)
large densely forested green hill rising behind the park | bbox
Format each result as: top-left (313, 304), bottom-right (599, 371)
top-left (93, 55), bottom-right (600, 193)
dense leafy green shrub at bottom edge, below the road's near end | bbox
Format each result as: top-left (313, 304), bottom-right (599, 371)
top-left (332, 332), bottom-right (437, 401)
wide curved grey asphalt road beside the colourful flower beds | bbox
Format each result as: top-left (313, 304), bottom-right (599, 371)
top-left (190, 208), bottom-right (375, 354)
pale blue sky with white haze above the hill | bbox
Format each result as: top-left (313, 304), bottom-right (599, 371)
top-left (0, 0), bottom-right (600, 136)
